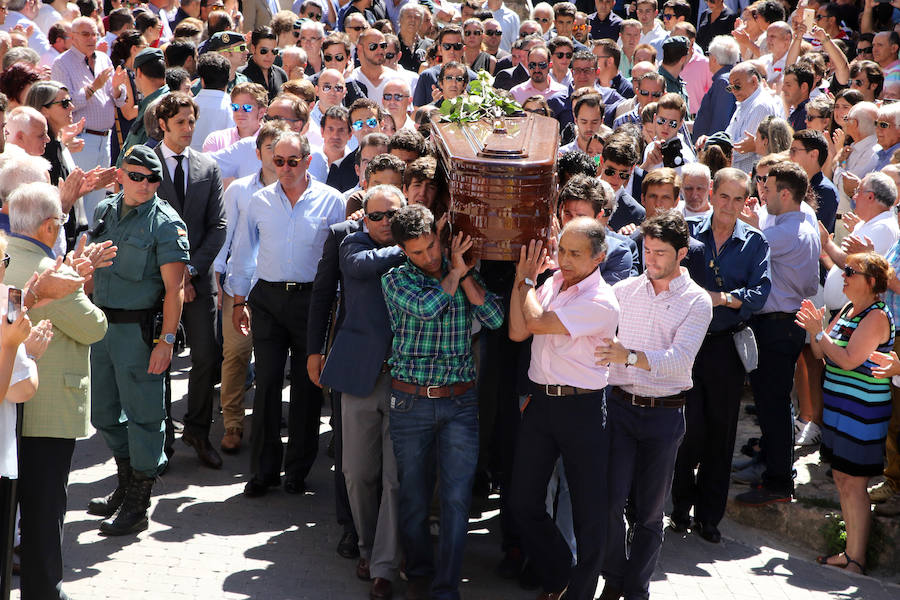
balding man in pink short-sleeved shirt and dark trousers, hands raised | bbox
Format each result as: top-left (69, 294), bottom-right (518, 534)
top-left (509, 217), bottom-right (619, 600)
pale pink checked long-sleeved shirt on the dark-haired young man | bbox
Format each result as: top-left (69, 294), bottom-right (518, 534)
top-left (609, 267), bottom-right (712, 398)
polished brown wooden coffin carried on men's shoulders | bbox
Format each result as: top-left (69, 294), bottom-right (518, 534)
top-left (432, 113), bottom-right (559, 261)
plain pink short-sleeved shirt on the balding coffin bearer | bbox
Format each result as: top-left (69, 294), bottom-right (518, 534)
top-left (528, 269), bottom-right (619, 390)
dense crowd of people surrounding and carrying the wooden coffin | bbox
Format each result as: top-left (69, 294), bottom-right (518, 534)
top-left (0, 0), bottom-right (900, 600)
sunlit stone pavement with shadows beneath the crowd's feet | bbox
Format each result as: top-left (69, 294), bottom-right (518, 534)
top-left (13, 358), bottom-right (900, 600)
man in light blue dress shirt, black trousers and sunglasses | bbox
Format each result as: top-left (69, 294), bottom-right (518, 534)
top-left (228, 131), bottom-right (345, 497)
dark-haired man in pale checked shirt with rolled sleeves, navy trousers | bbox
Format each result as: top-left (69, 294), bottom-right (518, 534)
top-left (595, 210), bottom-right (712, 598)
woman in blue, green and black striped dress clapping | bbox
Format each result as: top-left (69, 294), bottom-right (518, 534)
top-left (797, 252), bottom-right (894, 572)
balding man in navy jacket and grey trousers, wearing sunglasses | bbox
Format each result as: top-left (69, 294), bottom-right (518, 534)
top-left (320, 185), bottom-right (406, 598)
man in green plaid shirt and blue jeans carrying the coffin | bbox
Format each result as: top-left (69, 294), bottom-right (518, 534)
top-left (381, 205), bottom-right (503, 600)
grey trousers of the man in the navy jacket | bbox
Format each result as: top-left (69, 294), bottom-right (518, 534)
top-left (341, 373), bottom-right (400, 581)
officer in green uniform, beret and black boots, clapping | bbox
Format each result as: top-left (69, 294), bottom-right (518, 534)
top-left (90, 145), bottom-right (189, 535)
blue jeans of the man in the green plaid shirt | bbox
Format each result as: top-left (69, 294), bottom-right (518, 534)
top-left (390, 388), bottom-right (478, 600)
